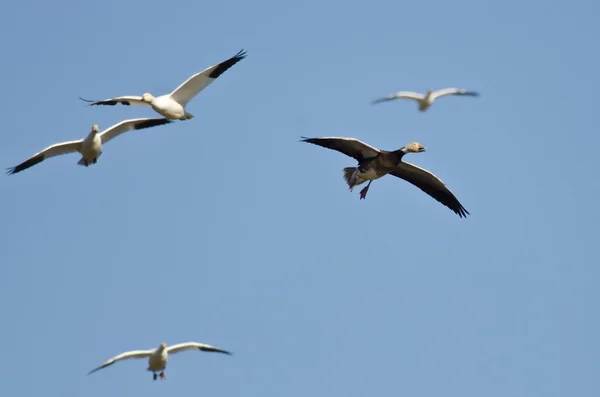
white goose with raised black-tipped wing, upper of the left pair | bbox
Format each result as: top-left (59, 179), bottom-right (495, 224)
top-left (79, 50), bottom-right (246, 120)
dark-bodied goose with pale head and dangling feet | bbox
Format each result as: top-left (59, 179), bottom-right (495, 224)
top-left (302, 137), bottom-right (469, 218)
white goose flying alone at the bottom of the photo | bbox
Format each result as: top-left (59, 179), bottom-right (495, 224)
top-left (88, 342), bottom-right (232, 380)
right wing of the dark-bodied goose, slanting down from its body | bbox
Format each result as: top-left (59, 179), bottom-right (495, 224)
top-left (390, 162), bottom-right (470, 218)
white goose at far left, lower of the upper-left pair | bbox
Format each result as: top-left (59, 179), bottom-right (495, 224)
top-left (7, 118), bottom-right (172, 175)
